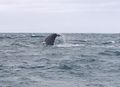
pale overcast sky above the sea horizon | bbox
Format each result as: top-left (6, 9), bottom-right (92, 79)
top-left (0, 0), bottom-right (120, 33)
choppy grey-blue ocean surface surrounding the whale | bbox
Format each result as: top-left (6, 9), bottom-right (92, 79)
top-left (0, 33), bottom-right (120, 87)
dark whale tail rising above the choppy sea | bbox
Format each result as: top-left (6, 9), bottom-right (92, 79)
top-left (45, 33), bottom-right (60, 45)
